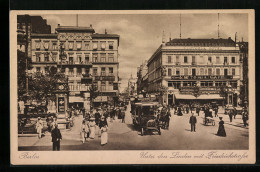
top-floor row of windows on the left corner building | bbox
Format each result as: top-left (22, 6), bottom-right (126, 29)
top-left (35, 41), bottom-right (114, 50)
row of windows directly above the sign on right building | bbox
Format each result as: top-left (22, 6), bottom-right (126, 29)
top-left (168, 68), bottom-right (236, 76)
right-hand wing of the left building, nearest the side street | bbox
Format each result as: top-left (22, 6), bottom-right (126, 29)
top-left (91, 31), bottom-right (119, 105)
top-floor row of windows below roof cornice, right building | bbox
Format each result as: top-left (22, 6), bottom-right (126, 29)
top-left (168, 56), bottom-right (236, 64)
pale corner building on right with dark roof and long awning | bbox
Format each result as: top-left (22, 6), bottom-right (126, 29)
top-left (147, 38), bottom-right (241, 105)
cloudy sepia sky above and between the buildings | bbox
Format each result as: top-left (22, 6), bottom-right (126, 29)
top-left (34, 13), bottom-right (248, 91)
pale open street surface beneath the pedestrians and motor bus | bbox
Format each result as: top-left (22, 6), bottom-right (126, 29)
top-left (18, 103), bottom-right (248, 151)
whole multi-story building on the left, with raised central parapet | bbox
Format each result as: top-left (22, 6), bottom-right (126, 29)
top-left (31, 25), bottom-right (119, 107)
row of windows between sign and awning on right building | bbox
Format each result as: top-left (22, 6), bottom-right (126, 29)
top-left (168, 81), bottom-right (237, 89)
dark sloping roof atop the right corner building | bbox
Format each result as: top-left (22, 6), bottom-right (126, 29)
top-left (166, 37), bottom-right (235, 46)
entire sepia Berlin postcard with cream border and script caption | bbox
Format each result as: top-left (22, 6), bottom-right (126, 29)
top-left (10, 10), bottom-right (256, 165)
